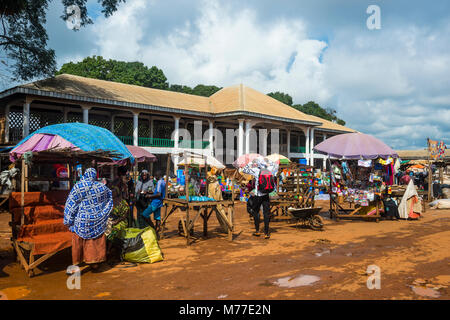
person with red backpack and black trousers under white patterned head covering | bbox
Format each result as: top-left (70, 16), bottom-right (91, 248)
top-left (243, 158), bottom-right (278, 239)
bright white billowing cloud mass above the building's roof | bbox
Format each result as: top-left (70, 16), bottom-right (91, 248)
top-left (92, 0), bottom-right (329, 102)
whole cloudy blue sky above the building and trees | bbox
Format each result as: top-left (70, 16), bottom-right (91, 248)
top-left (3, 0), bottom-right (450, 149)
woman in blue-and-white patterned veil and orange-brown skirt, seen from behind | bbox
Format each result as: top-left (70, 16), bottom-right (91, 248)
top-left (64, 168), bottom-right (113, 269)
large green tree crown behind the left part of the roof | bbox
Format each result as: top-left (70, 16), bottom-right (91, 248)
top-left (56, 56), bottom-right (169, 89)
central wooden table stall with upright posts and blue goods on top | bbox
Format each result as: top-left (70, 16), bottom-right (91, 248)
top-left (160, 151), bottom-right (234, 245)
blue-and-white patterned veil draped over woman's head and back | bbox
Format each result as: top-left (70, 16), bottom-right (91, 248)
top-left (64, 168), bottom-right (113, 239)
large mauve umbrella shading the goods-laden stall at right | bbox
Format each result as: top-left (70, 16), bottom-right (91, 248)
top-left (314, 132), bottom-right (398, 159)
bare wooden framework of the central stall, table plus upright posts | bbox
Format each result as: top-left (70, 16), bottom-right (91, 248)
top-left (159, 151), bottom-right (234, 245)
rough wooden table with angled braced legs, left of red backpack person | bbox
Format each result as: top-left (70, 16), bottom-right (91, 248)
top-left (160, 199), bottom-right (234, 245)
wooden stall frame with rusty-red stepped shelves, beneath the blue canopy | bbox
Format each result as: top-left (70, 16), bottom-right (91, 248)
top-left (9, 149), bottom-right (116, 277)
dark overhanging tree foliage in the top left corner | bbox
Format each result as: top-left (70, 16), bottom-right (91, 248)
top-left (0, 0), bottom-right (125, 80)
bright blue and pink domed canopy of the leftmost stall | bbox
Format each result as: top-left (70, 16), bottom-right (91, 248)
top-left (9, 122), bottom-right (134, 163)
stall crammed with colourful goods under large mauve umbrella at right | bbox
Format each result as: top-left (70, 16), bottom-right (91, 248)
top-left (314, 132), bottom-right (398, 222)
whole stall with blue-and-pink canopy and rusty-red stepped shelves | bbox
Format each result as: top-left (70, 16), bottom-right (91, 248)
top-left (9, 123), bottom-right (134, 276)
